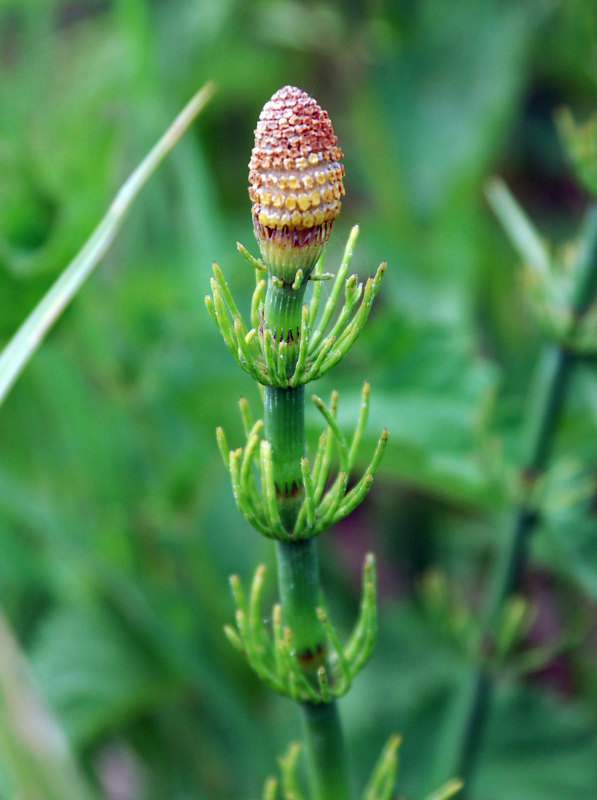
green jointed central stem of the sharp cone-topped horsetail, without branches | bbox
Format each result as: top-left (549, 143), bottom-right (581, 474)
top-left (264, 270), bottom-right (350, 800)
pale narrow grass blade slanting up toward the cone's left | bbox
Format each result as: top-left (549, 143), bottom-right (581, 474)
top-left (0, 82), bottom-right (214, 404)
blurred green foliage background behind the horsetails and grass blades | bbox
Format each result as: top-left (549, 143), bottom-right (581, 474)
top-left (0, 0), bottom-right (597, 800)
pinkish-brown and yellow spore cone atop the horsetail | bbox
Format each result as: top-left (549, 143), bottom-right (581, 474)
top-left (249, 86), bottom-right (344, 282)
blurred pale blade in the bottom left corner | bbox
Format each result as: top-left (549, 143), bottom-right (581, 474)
top-left (0, 615), bottom-right (96, 800)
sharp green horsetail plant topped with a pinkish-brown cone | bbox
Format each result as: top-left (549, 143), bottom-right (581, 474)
top-left (206, 86), bottom-right (460, 800)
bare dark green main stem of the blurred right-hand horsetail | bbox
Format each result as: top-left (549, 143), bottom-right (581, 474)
top-left (440, 206), bottom-right (597, 797)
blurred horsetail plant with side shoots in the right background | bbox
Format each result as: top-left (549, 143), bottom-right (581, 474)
top-left (430, 122), bottom-right (597, 796)
